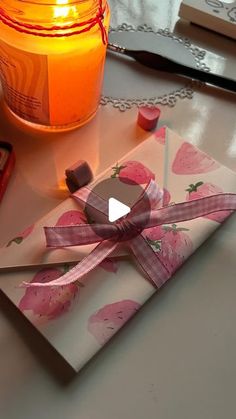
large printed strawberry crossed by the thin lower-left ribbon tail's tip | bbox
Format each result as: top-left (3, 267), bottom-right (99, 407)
top-left (18, 269), bottom-right (79, 320)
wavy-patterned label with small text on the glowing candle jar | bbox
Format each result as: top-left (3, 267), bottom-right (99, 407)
top-left (0, 41), bottom-right (50, 125)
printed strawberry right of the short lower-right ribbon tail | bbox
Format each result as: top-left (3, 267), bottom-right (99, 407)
top-left (145, 224), bottom-right (193, 273)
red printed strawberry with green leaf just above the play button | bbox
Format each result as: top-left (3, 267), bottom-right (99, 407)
top-left (111, 161), bottom-right (155, 185)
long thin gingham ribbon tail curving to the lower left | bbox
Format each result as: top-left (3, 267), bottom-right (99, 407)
top-left (22, 240), bottom-right (117, 288)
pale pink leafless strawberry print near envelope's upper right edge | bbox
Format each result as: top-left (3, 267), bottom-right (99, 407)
top-left (172, 142), bottom-right (220, 175)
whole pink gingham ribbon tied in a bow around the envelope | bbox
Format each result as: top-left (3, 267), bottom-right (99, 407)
top-left (24, 180), bottom-right (236, 288)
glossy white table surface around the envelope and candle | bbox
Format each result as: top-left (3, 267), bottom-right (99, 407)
top-left (0, 0), bottom-right (236, 419)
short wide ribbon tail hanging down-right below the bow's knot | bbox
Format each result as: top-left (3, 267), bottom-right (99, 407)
top-left (129, 234), bottom-right (171, 288)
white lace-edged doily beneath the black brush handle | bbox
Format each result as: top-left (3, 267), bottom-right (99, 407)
top-left (101, 23), bottom-right (209, 111)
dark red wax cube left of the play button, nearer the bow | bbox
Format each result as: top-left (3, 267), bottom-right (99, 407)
top-left (65, 160), bottom-right (93, 193)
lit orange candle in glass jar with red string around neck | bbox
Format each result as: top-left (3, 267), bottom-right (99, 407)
top-left (0, 0), bottom-right (109, 130)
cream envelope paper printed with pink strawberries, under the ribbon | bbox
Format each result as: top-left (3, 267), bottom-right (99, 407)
top-left (0, 127), bottom-right (236, 371)
